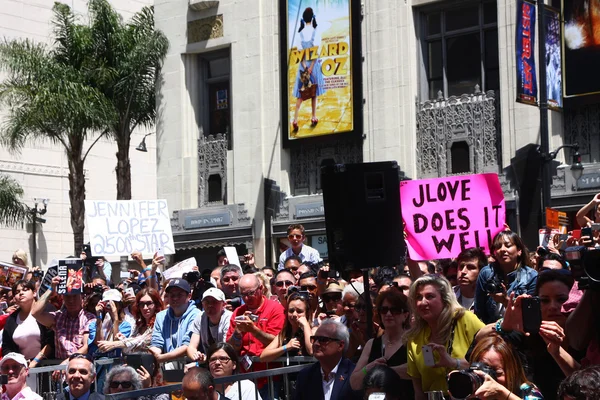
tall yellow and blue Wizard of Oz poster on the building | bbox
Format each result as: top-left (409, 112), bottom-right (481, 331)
top-left (282, 0), bottom-right (354, 140)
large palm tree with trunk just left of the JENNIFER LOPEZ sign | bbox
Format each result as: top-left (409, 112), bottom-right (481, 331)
top-left (0, 3), bottom-right (114, 254)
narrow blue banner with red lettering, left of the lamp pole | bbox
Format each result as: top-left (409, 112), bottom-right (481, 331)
top-left (515, 0), bottom-right (537, 105)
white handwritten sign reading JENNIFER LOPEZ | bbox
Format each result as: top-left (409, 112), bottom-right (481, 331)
top-left (85, 200), bottom-right (175, 256)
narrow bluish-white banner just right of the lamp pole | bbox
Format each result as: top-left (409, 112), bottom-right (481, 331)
top-left (544, 6), bottom-right (562, 110)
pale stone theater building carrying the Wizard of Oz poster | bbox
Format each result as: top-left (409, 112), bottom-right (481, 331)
top-left (155, 0), bottom-right (600, 267)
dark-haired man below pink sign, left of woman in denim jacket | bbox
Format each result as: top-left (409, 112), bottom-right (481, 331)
top-left (454, 247), bottom-right (487, 311)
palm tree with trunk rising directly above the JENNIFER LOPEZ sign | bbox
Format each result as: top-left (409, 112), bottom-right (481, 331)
top-left (89, 0), bottom-right (169, 200)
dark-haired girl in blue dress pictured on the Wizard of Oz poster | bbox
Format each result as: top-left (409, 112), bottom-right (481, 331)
top-left (292, 7), bottom-right (325, 132)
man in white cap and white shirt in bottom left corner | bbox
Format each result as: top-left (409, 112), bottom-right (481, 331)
top-left (0, 353), bottom-right (42, 400)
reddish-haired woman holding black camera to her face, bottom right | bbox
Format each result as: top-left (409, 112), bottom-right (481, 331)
top-left (448, 333), bottom-right (544, 400)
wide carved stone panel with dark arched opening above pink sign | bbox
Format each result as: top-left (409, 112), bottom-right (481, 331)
top-left (417, 89), bottom-right (500, 178)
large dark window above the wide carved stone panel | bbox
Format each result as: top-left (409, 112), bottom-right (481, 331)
top-left (422, 1), bottom-right (500, 99)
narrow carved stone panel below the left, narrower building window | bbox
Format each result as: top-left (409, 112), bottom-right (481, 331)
top-left (198, 133), bottom-right (227, 207)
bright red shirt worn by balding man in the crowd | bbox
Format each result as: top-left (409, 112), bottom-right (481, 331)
top-left (227, 296), bottom-right (285, 356)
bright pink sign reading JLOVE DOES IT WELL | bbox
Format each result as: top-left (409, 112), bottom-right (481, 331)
top-left (400, 174), bottom-right (506, 260)
